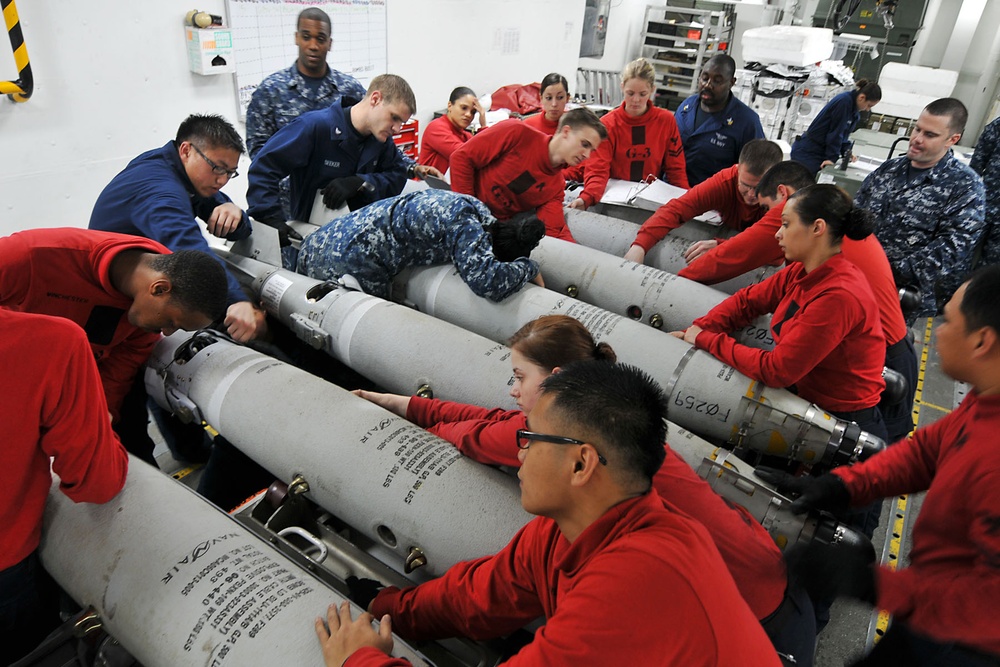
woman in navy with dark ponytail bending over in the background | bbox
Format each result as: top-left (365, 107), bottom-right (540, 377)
top-left (792, 79), bottom-right (882, 175)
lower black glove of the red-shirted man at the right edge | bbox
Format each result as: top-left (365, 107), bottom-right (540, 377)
top-left (785, 540), bottom-right (875, 604)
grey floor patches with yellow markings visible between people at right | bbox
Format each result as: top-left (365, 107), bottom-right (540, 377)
top-left (815, 318), bottom-right (952, 667)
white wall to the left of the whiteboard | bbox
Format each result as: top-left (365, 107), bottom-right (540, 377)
top-left (0, 0), bottom-right (238, 233)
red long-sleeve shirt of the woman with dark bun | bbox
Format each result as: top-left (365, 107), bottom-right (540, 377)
top-left (694, 254), bottom-right (885, 412)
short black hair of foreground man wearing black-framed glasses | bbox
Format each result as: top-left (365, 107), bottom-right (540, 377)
top-left (541, 360), bottom-right (667, 490)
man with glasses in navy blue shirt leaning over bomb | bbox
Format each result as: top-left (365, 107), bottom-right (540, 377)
top-left (88, 115), bottom-right (267, 342)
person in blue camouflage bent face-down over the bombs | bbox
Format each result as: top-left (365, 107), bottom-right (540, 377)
top-left (297, 190), bottom-right (545, 301)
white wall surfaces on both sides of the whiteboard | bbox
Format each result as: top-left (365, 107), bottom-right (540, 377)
top-left (0, 0), bottom-right (584, 234)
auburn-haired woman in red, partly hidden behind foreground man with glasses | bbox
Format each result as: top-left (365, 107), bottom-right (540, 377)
top-left (355, 315), bottom-right (816, 667)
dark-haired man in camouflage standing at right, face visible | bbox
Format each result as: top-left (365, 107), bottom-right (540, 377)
top-left (855, 98), bottom-right (985, 324)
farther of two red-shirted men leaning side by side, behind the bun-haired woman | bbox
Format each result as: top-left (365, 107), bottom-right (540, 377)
top-left (625, 139), bottom-right (781, 264)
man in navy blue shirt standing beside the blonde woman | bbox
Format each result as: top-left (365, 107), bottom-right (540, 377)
top-left (674, 55), bottom-right (764, 187)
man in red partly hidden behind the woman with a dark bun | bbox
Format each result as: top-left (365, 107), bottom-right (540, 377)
top-left (678, 161), bottom-right (917, 442)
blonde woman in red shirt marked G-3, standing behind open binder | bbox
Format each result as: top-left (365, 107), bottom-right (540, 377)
top-left (569, 58), bottom-right (688, 209)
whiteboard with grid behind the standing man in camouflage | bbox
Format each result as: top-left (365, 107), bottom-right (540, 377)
top-left (227, 0), bottom-right (388, 120)
